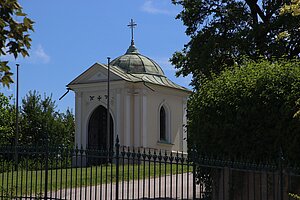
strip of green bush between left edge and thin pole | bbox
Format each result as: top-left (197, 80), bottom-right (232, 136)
top-left (0, 93), bottom-right (15, 145)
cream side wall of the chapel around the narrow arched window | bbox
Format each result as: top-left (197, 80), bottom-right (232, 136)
top-left (143, 84), bottom-right (186, 151)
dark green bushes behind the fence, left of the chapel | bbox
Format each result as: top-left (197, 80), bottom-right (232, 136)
top-left (0, 91), bottom-right (75, 147)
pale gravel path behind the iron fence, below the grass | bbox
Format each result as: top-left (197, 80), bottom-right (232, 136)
top-left (48, 173), bottom-right (197, 200)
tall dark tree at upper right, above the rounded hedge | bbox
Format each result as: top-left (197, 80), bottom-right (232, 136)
top-left (171, 0), bottom-right (300, 89)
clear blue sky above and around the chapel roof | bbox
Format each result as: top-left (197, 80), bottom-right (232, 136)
top-left (1, 0), bottom-right (191, 111)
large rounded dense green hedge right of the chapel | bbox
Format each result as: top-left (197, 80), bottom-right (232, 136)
top-left (188, 60), bottom-right (300, 162)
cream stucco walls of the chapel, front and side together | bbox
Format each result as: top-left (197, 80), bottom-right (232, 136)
top-left (73, 81), bottom-right (188, 152)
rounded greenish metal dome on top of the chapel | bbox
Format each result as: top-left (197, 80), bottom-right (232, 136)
top-left (111, 44), bottom-right (165, 76)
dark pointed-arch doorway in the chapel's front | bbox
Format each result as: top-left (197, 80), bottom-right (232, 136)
top-left (88, 105), bottom-right (114, 164)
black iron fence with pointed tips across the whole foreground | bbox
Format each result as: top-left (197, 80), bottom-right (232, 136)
top-left (0, 138), bottom-right (300, 200)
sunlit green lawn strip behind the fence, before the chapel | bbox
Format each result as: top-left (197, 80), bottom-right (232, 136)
top-left (0, 163), bottom-right (192, 196)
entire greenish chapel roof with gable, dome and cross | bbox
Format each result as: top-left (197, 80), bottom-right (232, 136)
top-left (68, 20), bottom-right (191, 93)
